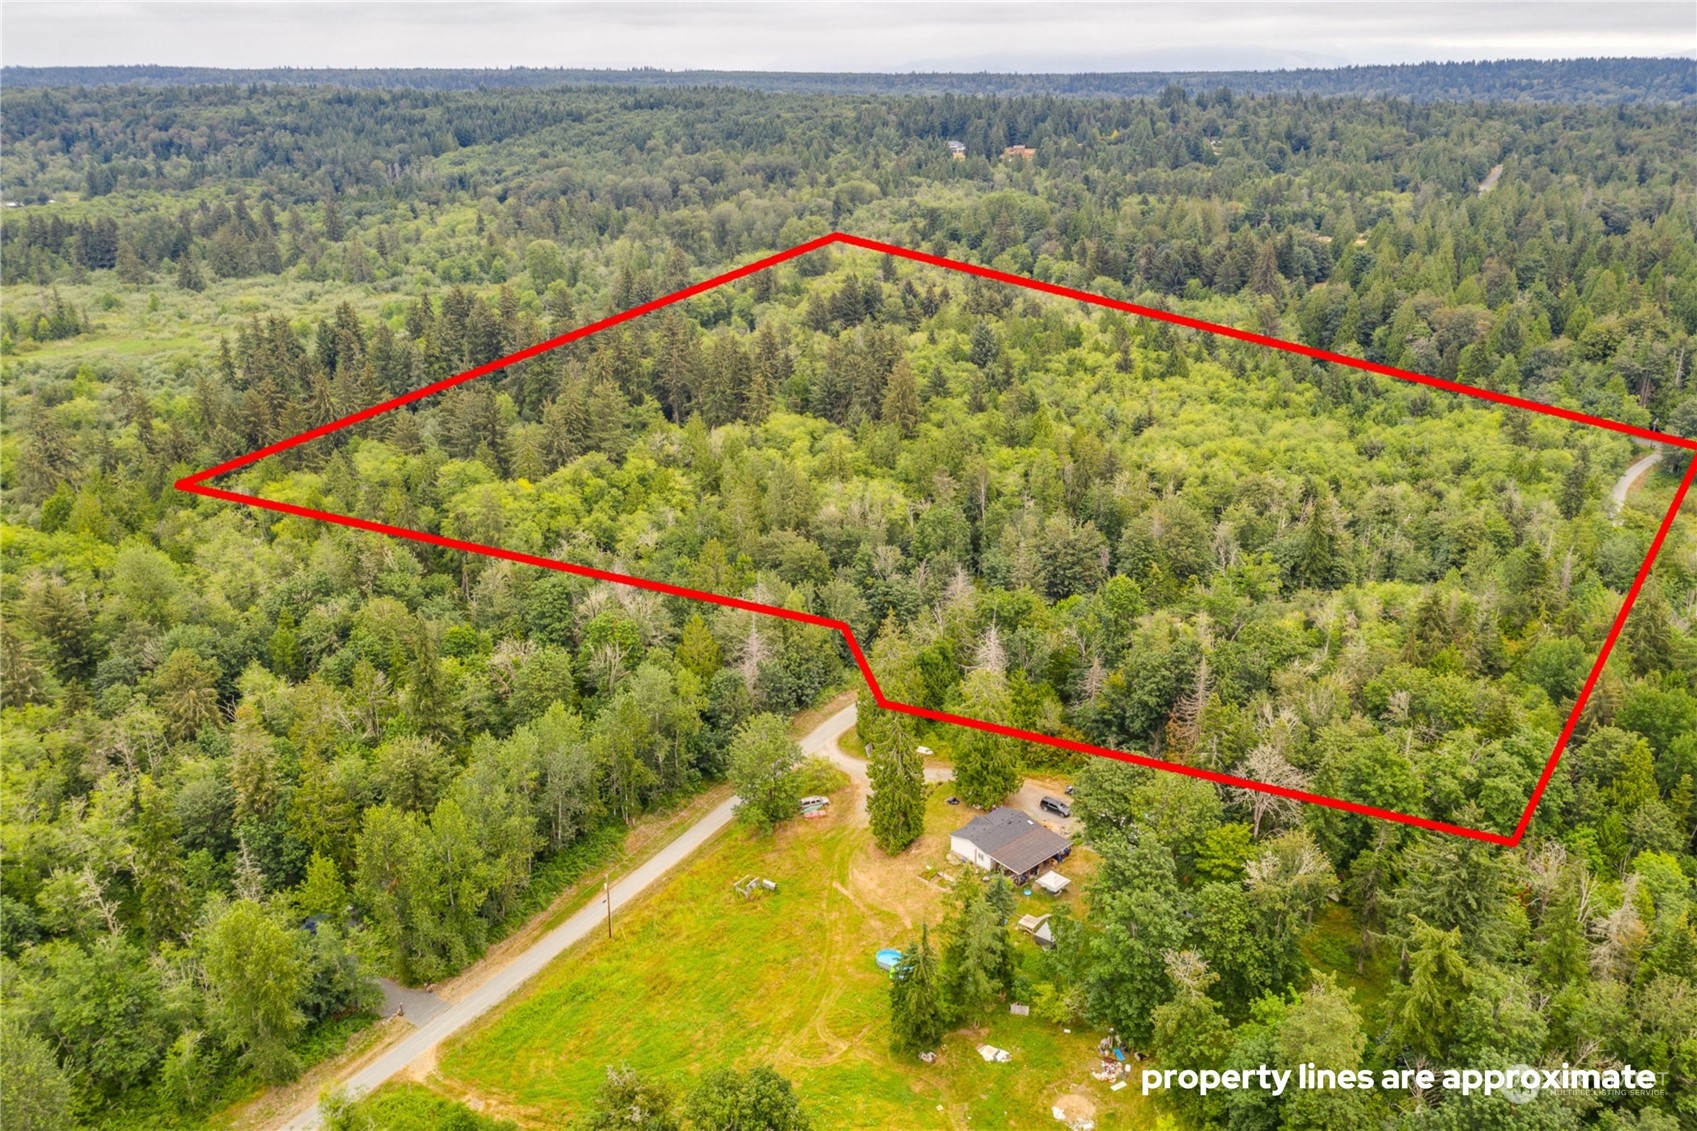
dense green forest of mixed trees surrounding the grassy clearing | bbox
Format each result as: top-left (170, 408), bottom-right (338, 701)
top-left (0, 74), bottom-right (1697, 1129)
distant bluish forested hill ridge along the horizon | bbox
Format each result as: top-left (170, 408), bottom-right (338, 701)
top-left (0, 58), bottom-right (1697, 104)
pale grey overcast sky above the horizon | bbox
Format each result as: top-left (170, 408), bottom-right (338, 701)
top-left (0, 0), bottom-right (1697, 71)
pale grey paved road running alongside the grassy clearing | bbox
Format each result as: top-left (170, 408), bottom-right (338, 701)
top-left (283, 705), bottom-right (865, 1129)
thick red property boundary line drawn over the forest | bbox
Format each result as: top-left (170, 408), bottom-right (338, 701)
top-left (176, 233), bottom-right (1697, 847)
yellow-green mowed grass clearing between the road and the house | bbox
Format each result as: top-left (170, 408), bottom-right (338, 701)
top-left (434, 774), bottom-right (1154, 1128)
